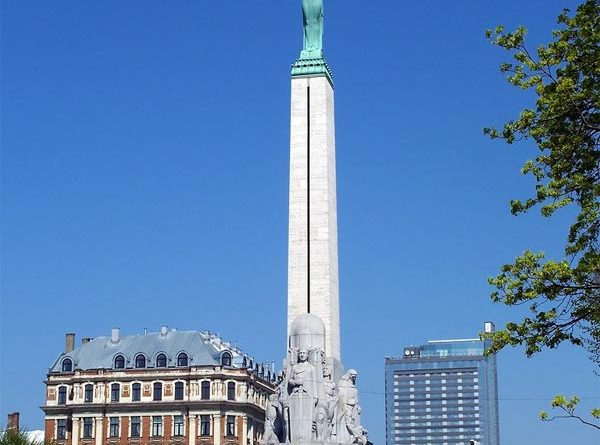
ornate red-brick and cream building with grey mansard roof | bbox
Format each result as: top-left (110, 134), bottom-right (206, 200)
top-left (42, 327), bottom-right (275, 445)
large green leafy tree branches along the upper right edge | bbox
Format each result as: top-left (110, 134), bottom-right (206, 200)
top-left (484, 0), bottom-right (600, 364)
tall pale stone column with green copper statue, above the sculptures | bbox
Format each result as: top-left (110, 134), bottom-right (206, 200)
top-left (288, 0), bottom-right (341, 364)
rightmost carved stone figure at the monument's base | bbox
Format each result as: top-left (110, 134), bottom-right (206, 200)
top-left (336, 369), bottom-right (367, 445)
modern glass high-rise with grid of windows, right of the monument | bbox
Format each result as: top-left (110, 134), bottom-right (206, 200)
top-left (385, 322), bottom-right (499, 445)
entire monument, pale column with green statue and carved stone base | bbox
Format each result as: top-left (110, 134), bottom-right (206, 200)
top-left (261, 0), bottom-right (367, 445)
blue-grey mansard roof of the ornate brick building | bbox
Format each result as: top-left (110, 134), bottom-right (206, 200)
top-left (50, 328), bottom-right (254, 372)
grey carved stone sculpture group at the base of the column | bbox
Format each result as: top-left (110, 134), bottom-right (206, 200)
top-left (261, 314), bottom-right (367, 445)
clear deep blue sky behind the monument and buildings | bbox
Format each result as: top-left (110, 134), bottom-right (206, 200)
top-left (0, 0), bottom-right (600, 445)
